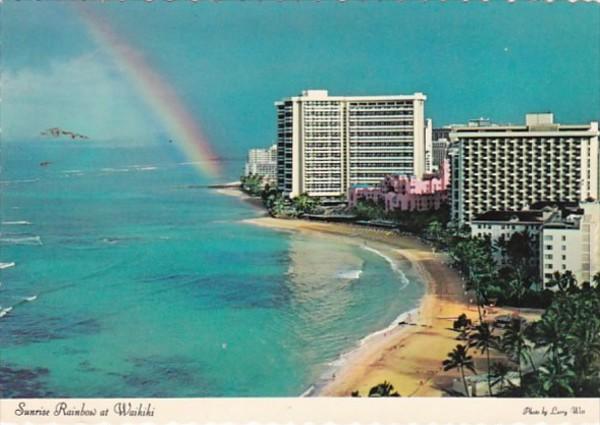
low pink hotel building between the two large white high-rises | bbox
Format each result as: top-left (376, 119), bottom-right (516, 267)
top-left (348, 159), bottom-right (450, 211)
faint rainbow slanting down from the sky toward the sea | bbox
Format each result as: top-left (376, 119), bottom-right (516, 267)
top-left (72, 6), bottom-right (220, 178)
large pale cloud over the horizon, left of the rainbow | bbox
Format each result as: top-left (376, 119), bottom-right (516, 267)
top-left (0, 52), bottom-right (159, 143)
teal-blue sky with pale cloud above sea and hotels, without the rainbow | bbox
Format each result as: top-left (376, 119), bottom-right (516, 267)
top-left (0, 0), bottom-right (600, 157)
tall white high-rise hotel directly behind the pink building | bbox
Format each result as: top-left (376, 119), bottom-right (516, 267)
top-left (275, 90), bottom-right (431, 198)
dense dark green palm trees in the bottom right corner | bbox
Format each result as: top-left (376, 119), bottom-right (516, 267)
top-left (442, 273), bottom-right (600, 397)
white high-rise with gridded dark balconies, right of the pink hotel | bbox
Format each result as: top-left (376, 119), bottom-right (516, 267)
top-left (450, 113), bottom-right (600, 225)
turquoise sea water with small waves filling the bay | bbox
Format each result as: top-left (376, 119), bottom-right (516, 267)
top-left (0, 141), bottom-right (424, 397)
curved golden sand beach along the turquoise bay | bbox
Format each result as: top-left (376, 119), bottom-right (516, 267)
top-left (244, 217), bottom-right (476, 396)
